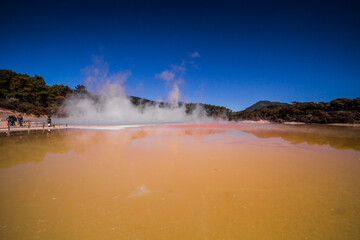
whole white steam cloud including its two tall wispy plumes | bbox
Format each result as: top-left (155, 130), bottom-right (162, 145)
top-left (55, 55), bottom-right (211, 125)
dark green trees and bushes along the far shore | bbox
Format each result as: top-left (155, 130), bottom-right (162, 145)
top-left (0, 70), bottom-right (360, 124)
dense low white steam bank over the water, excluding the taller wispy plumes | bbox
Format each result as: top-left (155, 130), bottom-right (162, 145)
top-left (61, 89), bottom-right (209, 125)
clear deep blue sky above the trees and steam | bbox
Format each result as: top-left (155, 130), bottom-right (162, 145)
top-left (0, 0), bottom-right (360, 110)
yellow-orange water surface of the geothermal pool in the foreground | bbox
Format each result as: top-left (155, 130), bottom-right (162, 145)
top-left (0, 124), bottom-right (360, 240)
